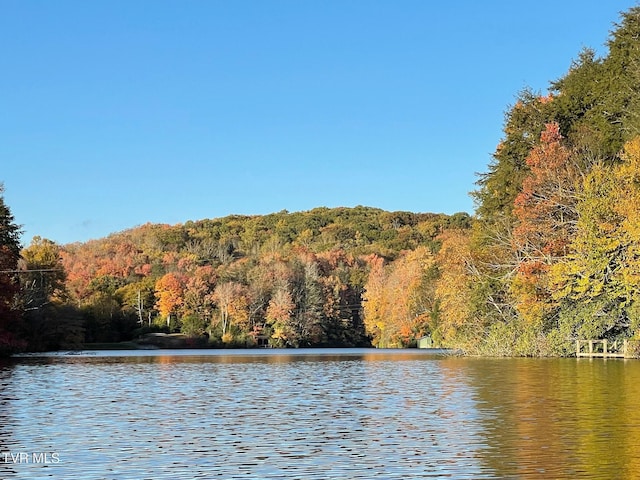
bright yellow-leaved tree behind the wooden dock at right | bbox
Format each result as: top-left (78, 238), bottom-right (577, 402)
top-left (551, 137), bottom-right (640, 351)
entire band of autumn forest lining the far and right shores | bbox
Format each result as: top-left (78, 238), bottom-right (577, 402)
top-left (0, 7), bottom-right (640, 356)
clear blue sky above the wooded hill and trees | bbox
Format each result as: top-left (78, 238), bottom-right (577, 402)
top-left (0, 0), bottom-right (635, 245)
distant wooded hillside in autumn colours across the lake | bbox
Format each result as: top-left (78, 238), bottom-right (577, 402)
top-left (11, 207), bottom-right (471, 348)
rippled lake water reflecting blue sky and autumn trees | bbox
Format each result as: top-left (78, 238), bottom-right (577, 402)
top-left (0, 349), bottom-right (640, 480)
